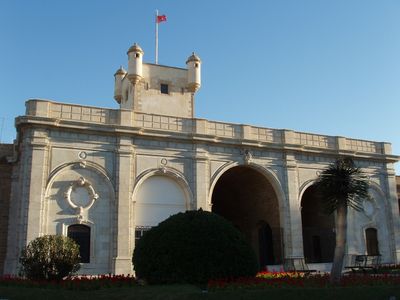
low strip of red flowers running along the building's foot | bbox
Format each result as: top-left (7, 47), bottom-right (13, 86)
top-left (0, 271), bottom-right (400, 291)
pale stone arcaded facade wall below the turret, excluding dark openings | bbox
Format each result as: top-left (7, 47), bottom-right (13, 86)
top-left (5, 101), bottom-right (400, 274)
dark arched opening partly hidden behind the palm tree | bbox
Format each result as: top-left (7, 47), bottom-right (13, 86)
top-left (301, 186), bottom-right (335, 263)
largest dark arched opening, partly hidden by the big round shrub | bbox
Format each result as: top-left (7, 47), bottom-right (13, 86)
top-left (212, 166), bottom-right (282, 268)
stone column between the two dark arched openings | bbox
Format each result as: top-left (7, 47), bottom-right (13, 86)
top-left (285, 154), bottom-right (304, 258)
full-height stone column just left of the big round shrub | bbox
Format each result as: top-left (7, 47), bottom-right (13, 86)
top-left (114, 137), bottom-right (134, 274)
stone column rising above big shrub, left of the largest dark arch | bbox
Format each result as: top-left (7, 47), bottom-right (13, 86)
top-left (193, 149), bottom-right (211, 211)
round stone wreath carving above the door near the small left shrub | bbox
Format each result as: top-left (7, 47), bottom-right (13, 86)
top-left (64, 177), bottom-right (99, 223)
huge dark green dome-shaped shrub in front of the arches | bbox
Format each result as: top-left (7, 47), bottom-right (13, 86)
top-left (132, 210), bottom-right (258, 284)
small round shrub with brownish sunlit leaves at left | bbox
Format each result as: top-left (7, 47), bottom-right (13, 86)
top-left (19, 235), bottom-right (80, 281)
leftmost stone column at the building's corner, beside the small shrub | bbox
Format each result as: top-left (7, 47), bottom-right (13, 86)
top-left (4, 129), bottom-right (49, 274)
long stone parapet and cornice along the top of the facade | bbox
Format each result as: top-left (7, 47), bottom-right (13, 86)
top-left (16, 100), bottom-right (400, 162)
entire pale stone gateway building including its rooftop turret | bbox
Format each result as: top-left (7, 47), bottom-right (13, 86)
top-left (0, 44), bottom-right (400, 274)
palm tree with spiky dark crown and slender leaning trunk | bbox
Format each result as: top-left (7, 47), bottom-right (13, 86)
top-left (315, 157), bottom-right (369, 283)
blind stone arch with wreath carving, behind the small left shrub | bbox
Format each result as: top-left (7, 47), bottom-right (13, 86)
top-left (44, 161), bottom-right (116, 274)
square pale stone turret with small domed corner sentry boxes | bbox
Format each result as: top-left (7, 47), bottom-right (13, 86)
top-left (114, 43), bottom-right (201, 118)
